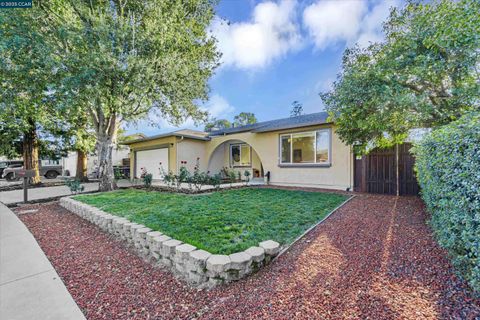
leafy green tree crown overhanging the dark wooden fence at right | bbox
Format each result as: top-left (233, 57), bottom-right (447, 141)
top-left (321, 0), bottom-right (480, 149)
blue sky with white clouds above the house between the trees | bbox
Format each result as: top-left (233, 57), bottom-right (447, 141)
top-left (128, 0), bottom-right (400, 135)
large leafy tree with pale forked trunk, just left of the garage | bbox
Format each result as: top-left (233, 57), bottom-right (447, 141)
top-left (31, 0), bottom-right (219, 190)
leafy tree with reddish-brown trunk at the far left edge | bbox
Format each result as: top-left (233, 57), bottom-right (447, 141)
top-left (0, 9), bottom-right (62, 183)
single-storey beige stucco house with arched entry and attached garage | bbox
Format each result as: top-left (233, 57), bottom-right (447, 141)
top-left (125, 112), bottom-right (354, 190)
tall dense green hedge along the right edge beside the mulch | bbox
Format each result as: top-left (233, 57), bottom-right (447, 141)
top-left (414, 113), bottom-right (480, 292)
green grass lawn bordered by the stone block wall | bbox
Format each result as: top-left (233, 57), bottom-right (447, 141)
top-left (75, 188), bottom-right (347, 254)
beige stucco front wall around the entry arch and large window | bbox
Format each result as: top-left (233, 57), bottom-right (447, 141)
top-left (206, 125), bottom-right (353, 190)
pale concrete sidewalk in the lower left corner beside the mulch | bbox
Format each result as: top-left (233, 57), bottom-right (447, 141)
top-left (0, 203), bottom-right (85, 320)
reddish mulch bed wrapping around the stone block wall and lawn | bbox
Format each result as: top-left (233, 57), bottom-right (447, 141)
top-left (16, 195), bottom-right (480, 319)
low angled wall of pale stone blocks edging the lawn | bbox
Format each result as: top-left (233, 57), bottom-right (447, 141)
top-left (60, 197), bottom-right (280, 287)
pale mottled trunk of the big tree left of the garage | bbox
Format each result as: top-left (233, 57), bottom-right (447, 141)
top-left (97, 135), bottom-right (117, 191)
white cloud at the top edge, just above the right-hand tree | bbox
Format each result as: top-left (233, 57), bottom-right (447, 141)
top-left (303, 0), bottom-right (400, 49)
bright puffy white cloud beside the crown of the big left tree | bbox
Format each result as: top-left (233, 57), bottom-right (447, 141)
top-left (212, 0), bottom-right (302, 69)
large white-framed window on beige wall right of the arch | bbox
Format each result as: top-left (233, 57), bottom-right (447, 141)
top-left (280, 129), bottom-right (330, 164)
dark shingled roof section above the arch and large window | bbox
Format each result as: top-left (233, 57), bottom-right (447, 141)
top-left (209, 112), bottom-right (330, 136)
